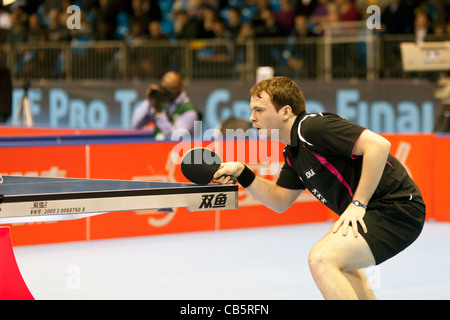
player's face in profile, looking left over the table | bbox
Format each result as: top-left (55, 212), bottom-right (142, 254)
top-left (250, 92), bottom-right (282, 140)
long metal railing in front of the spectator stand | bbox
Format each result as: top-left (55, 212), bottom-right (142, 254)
top-left (0, 21), bottom-right (445, 81)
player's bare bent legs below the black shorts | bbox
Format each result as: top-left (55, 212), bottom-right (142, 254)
top-left (308, 226), bottom-right (375, 299)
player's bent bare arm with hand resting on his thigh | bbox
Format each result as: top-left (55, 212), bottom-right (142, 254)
top-left (333, 129), bottom-right (391, 236)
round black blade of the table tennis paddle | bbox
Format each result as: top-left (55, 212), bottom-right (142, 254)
top-left (181, 148), bottom-right (222, 184)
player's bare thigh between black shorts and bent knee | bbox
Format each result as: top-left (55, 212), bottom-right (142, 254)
top-left (310, 227), bottom-right (375, 271)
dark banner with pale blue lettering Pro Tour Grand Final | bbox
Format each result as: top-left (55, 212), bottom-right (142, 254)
top-left (12, 80), bottom-right (439, 133)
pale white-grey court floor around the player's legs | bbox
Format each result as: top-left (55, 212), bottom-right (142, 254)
top-left (14, 221), bottom-right (450, 300)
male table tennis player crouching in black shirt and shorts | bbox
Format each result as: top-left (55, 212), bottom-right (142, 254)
top-left (213, 77), bottom-right (425, 299)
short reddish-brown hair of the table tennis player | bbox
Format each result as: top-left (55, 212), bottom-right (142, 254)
top-left (250, 77), bottom-right (306, 115)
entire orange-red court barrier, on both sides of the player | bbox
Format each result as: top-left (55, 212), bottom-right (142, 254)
top-left (0, 134), bottom-right (450, 245)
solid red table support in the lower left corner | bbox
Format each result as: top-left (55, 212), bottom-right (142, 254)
top-left (0, 227), bottom-right (34, 300)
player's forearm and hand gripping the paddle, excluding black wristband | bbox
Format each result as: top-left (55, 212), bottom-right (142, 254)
top-left (213, 162), bottom-right (303, 213)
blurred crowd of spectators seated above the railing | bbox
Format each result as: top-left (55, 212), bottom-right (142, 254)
top-left (0, 0), bottom-right (450, 44)
